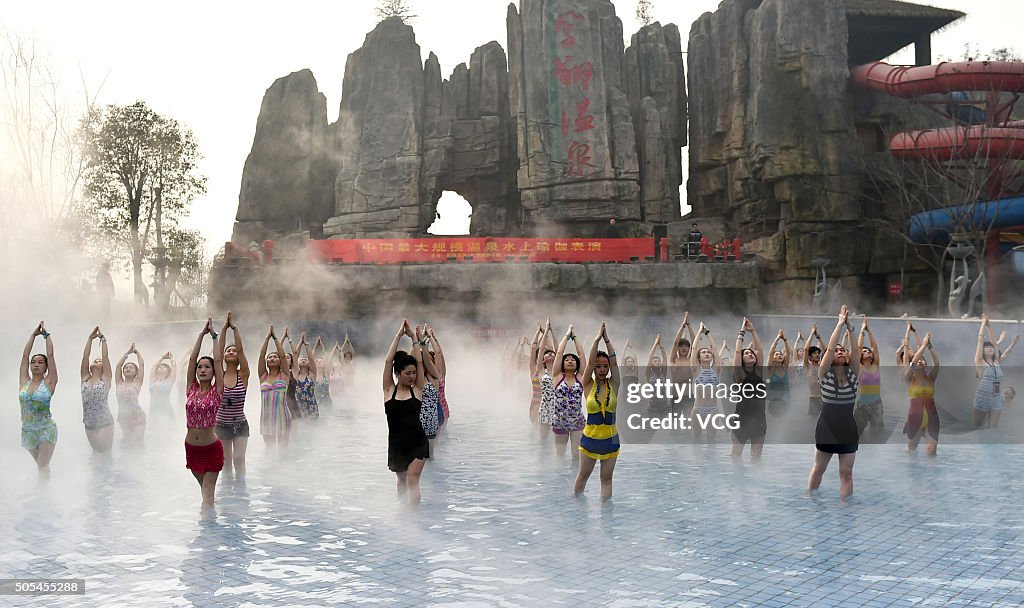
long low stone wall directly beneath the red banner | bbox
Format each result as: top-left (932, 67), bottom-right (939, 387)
top-left (210, 257), bottom-right (761, 319)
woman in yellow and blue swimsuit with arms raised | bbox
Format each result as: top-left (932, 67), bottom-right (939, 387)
top-left (572, 322), bottom-right (620, 500)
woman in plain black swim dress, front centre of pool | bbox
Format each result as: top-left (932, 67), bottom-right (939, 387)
top-left (384, 319), bottom-right (430, 505)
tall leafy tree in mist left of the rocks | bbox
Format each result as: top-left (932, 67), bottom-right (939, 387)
top-left (80, 101), bottom-right (206, 301)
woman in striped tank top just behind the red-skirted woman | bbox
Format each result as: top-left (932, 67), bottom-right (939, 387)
top-left (216, 311), bottom-right (250, 478)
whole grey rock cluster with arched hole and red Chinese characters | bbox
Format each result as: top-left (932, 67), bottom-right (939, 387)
top-left (236, 0), bottom-right (686, 241)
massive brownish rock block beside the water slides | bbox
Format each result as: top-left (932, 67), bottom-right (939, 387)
top-left (687, 0), bottom-right (868, 300)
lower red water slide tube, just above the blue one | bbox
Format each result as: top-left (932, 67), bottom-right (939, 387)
top-left (889, 126), bottom-right (1024, 161)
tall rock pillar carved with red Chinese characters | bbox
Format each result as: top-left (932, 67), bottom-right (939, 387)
top-left (507, 0), bottom-right (641, 233)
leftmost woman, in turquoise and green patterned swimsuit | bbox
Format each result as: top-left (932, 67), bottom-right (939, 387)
top-left (18, 321), bottom-right (57, 468)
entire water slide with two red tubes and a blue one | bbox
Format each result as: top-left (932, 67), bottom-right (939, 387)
top-left (851, 61), bottom-right (1024, 243)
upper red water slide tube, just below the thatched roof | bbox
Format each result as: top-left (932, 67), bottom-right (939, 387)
top-left (850, 61), bottom-right (1024, 98)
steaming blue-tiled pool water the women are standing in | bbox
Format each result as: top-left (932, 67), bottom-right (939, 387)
top-left (0, 360), bottom-right (1024, 607)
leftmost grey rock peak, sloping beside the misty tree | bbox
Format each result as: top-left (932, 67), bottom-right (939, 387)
top-left (231, 70), bottom-right (334, 244)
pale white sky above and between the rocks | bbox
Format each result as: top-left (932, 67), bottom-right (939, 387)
top-left (0, 0), bottom-right (1021, 255)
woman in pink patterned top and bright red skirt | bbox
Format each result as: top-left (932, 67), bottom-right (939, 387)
top-left (185, 318), bottom-right (224, 510)
